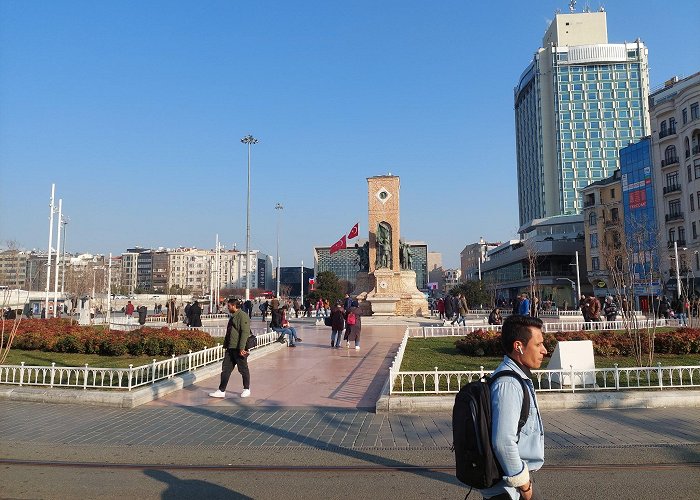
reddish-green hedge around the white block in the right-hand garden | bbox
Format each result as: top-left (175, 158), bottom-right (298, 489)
top-left (455, 328), bottom-right (700, 357)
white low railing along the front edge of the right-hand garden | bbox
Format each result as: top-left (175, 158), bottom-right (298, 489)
top-left (389, 363), bottom-right (700, 394)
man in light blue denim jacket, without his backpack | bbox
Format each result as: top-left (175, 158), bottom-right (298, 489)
top-left (481, 315), bottom-right (547, 500)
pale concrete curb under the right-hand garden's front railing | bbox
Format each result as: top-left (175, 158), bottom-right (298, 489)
top-left (376, 388), bottom-right (700, 414)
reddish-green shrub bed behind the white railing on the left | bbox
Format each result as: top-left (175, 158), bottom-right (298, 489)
top-left (6, 319), bottom-right (216, 356)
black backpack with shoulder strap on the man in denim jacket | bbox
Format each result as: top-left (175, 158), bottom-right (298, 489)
top-left (452, 370), bottom-right (530, 496)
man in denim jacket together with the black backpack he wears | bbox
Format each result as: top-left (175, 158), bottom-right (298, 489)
top-left (452, 315), bottom-right (547, 500)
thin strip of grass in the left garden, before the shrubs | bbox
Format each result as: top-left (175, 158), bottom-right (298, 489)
top-left (5, 349), bottom-right (169, 368)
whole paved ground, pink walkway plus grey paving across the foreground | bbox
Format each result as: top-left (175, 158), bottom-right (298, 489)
top-left (0, 323), bottom-right (700, 498)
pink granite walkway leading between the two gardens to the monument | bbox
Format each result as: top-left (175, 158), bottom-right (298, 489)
top-left (150, 324), bottom-right (406, 408)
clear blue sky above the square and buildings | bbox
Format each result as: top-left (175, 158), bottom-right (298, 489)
top-left (0, 0), bottom-right (700, 267)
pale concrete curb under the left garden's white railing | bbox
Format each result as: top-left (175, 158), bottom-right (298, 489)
top-left (0, 342), bottom-right (286, 408)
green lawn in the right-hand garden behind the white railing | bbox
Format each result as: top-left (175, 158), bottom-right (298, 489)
top-left (401, 337), bottom-right (700, 371)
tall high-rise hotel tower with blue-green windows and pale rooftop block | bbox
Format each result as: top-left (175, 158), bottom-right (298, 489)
top-left (515, 12), bottom-right (650, 226)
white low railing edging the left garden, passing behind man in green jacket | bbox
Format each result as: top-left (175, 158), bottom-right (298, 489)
top-left (0, 332), bottom-right (278, 391)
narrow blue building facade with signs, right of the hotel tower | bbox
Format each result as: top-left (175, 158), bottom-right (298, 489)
top-left (620, 137), bottom-right (659, 294)
